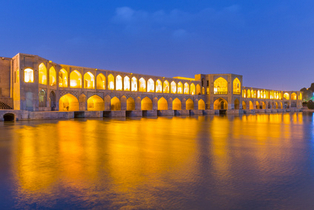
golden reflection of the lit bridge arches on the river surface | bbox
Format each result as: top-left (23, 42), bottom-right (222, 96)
top-left (8, 113), bottom-right (304, 208)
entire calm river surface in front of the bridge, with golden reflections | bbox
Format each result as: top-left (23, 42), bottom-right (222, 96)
top-left (0, 113), bottom-right (314, 210)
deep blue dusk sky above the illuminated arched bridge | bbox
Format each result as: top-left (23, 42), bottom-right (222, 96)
top-left (0, 0), bottom-right (314, 90)
